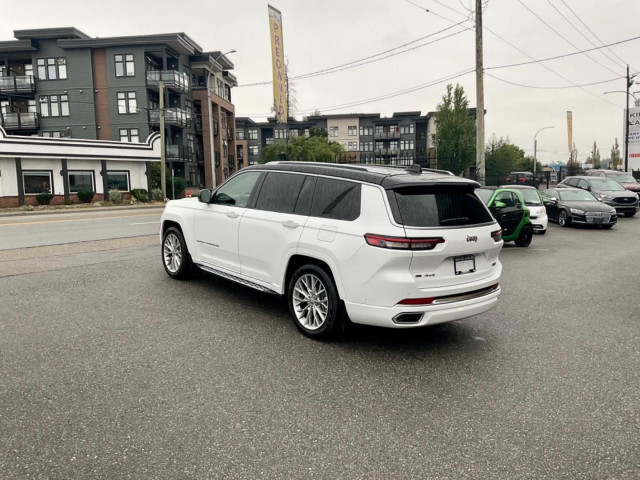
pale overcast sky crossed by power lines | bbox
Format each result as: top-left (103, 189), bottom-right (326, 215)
top-left (0, 0), bottom-right (640, 163)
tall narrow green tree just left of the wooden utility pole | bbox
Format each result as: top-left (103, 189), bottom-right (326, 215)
top-left (434, 84), bottom-right (476, 173)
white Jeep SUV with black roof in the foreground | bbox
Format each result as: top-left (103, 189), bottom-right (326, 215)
top-left (160, 162), bottom-right (503, 338)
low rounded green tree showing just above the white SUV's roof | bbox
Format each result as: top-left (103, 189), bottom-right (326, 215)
top-left (259, 135), bottom-right (344, 163)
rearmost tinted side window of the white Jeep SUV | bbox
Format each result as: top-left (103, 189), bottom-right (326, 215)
top-left (311, 178), bottom-right (361, 221)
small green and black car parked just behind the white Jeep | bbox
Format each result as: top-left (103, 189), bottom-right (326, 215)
top-left (476, 187), bottom-right (533, 247)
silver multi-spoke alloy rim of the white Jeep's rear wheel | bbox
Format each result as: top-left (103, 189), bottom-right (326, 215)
top-left (292, 273), bottom-right (329, 330)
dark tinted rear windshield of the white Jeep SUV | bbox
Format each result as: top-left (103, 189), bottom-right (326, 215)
top-left (388, 185), bottom-right (493, 227)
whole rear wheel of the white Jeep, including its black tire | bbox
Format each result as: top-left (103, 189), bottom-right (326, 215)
top-left (287, 264), bottom-right (342, 340)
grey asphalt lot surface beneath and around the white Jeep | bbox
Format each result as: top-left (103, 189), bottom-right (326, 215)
top-left (0, 218), bottom-right (640, 479)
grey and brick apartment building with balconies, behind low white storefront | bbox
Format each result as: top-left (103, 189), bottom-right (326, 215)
top-left (0, 27), bottom-right (242, 190)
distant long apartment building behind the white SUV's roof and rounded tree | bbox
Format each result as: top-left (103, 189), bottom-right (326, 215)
top-left (236, 111), bottom-right (437, 167)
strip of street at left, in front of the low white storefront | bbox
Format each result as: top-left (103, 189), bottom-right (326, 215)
top-left (0, 207), bottom-right (164, 250)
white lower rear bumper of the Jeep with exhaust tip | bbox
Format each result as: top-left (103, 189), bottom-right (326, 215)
top-left (344, 287), bottom-right (501, 328)
